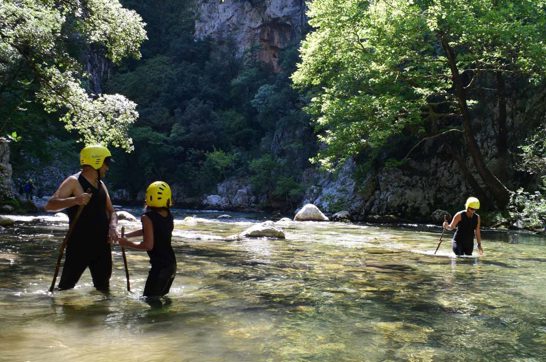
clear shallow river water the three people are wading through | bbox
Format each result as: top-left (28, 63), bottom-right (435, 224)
top-left (0, 215), bottom-right (546, 361)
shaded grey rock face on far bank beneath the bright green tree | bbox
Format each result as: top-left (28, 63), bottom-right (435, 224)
top-left (304, 158), bottom-right (472, 222)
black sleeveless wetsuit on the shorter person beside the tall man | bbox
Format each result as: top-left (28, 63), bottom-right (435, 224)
top-left (144, 209), bottom-right (176, 297)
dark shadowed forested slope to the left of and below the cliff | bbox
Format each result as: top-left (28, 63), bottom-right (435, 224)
top-left (102, 1), bottom-right (313, 204)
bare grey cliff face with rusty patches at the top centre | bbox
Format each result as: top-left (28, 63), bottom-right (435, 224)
top-left (195, 0), bottom-right (307, 71)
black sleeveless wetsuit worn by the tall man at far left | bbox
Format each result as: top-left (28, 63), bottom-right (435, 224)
top-left (59, 174), bottom-right (112, 291)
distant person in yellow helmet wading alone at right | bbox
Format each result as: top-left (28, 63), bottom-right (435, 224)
top-left (443, 197), bottom-right (483, 255)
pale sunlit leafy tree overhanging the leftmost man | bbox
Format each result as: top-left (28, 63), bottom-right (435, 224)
top-left (0, 0), bottom-right (146, 150)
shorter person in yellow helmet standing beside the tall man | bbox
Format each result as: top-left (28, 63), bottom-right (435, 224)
top-left (118, 181), bottom-right (176, 298)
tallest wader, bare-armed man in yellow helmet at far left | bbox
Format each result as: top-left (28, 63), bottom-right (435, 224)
top-left (45, 145), bottom-right (118, 292)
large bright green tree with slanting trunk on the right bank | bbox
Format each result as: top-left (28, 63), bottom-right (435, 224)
top-left (293, 0), bottom-right (546, 207)
